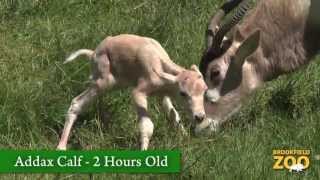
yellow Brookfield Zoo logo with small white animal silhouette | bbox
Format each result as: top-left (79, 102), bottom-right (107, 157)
top-left (272, 150), bottom-right (310, 172)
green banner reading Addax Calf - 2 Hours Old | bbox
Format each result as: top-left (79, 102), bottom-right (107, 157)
top-left (0, 150), bottom-right (181, 173)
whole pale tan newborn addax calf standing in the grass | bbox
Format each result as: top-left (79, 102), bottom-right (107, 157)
top-left (57, 34), bottom-right (207, 150)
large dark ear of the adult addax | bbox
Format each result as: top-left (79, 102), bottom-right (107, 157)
top-left (234, 30), bottom-right (260, 66)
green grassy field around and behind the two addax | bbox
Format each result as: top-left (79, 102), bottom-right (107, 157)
top-left (0, 0), bottom-right (320, 180)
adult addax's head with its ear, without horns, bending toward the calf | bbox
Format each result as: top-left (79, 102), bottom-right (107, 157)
top-left (205, 29), bottom-right (260, 103)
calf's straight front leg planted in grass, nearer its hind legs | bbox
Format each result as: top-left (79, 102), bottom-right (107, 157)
top-left (132, 88), bottom-right (154, 150)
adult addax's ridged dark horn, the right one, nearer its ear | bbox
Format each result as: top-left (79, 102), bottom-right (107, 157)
top-left (212, 0), bottom-right (251, 50)
